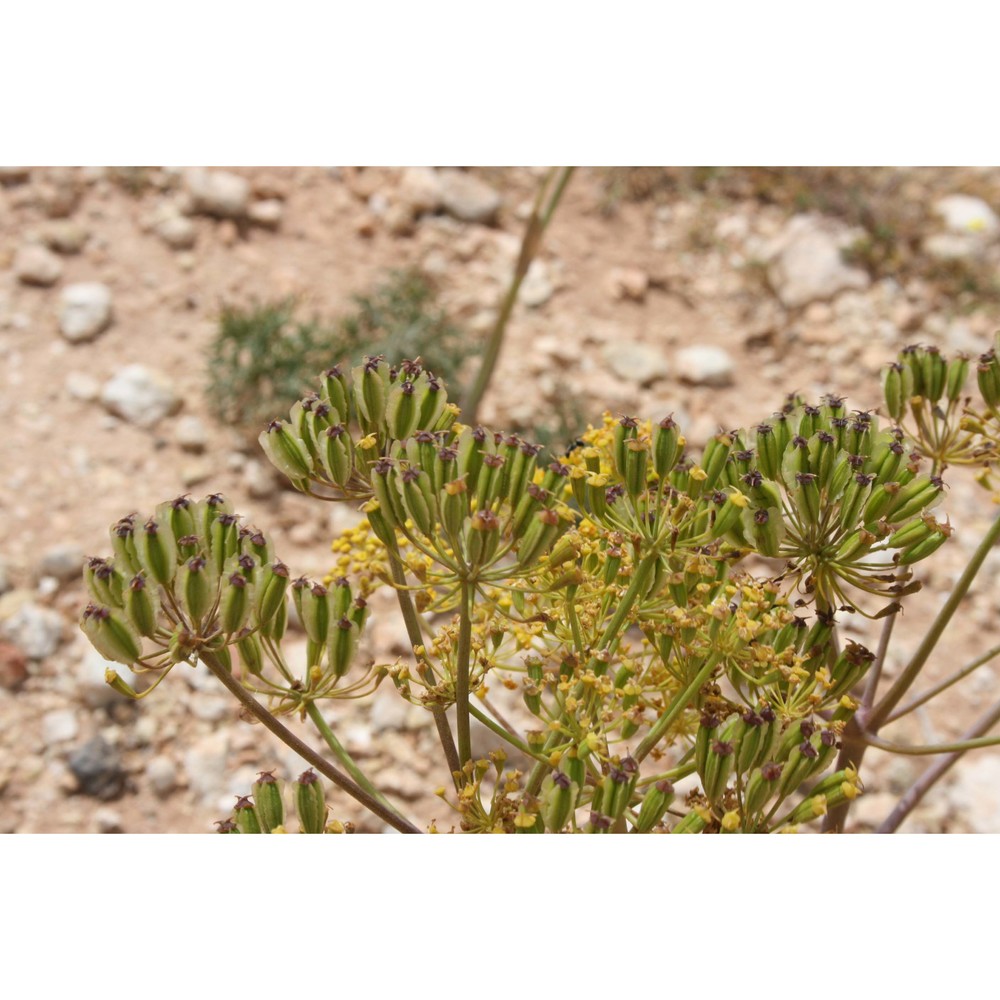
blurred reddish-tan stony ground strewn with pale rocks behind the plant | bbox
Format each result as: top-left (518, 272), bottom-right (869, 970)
top-left (0, 167), bottom-right (1000, 833)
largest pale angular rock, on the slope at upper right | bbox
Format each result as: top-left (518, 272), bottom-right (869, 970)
top-left (767, 215), bottom-right (870, 308)
